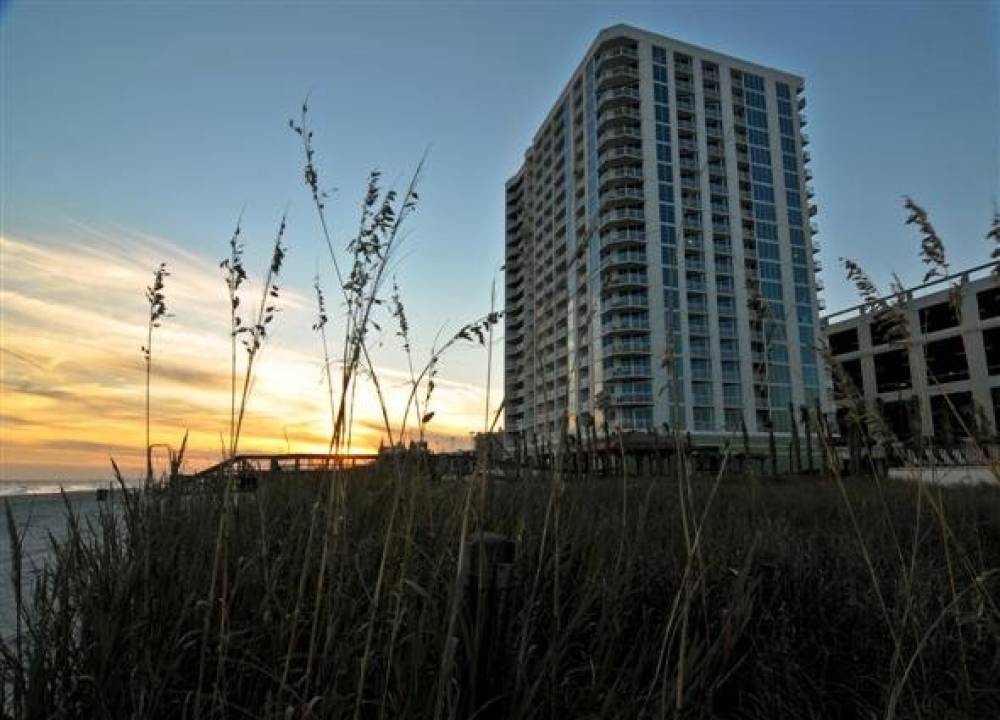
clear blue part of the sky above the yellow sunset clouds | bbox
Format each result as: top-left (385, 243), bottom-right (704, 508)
top-left (0, 0), bottom-right (1000, 476)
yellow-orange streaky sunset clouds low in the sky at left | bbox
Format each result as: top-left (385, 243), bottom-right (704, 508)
top-left (0, 228), bottom-right (496, 480)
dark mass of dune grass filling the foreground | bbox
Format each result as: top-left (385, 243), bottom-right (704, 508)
top-left (0, 468), bottom-right (1000, 718)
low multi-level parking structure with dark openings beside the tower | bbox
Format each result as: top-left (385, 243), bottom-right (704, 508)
top-left (822, 263), bottom-right (1000, 441)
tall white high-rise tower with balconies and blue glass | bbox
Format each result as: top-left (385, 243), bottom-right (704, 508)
top-left (505, 25), bottom-right (830, 440)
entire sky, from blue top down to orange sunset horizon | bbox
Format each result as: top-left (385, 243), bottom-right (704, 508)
top-left (0, 1), bottom-right (1000, 482)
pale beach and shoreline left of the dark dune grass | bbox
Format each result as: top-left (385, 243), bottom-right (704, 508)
top-left (0, 490), bottom-right (120, 638)
